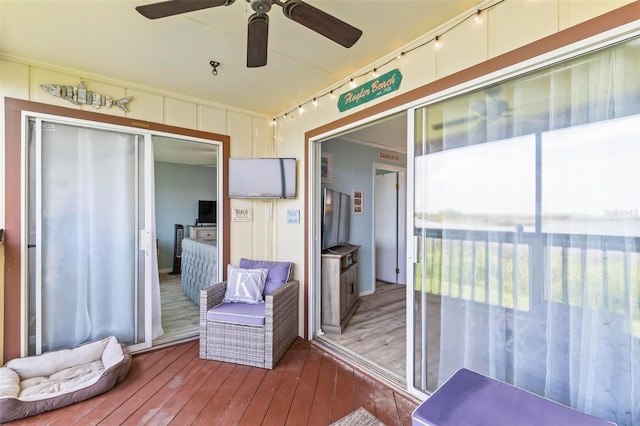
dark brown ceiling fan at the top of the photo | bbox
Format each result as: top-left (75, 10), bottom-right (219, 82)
top-left (136, 0), bottom-right (362, 68)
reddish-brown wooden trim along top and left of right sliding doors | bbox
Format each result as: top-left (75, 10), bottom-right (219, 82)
top-left (304, 0), bottom-right (640, 340)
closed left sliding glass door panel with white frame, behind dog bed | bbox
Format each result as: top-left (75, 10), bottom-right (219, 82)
top-left (27, 118), bottom-right (153, 354)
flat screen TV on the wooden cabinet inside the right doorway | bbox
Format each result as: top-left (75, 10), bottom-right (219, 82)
top-left (322, 188), bottom-right (351, 250)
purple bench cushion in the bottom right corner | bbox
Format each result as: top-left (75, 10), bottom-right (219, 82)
top-left (412, 368), bottom-right (611, 426)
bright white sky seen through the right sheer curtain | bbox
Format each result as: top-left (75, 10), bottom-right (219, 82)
top-left (415, 116), bottom-right (640, 217)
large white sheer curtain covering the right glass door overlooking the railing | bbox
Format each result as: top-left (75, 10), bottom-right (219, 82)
top-left (416, 39), bottom-right (640, 426)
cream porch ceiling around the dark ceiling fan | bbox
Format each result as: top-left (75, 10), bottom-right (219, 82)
top-left (0, 0), bottom-right (480, 116)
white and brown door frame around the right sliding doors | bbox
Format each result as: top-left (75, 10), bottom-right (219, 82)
top-left (304, 13), bottom-right (639, 399)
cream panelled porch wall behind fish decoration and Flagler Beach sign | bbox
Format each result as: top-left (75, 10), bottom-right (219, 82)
top-left (0, 0), bottom-right (633, 344)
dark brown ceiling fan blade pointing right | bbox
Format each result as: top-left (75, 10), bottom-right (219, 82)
top-left (282, 0), bottom-right (362, 47)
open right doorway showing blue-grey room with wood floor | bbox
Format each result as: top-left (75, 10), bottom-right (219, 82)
top-left (313, 112), bottom-right (407, 388)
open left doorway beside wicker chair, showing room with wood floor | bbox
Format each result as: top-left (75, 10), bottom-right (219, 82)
top-left (153, 136), bottom-right (222, 347)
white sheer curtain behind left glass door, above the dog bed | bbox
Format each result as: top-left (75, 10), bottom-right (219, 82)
top-left (30, 123), bottom-right (162, 352)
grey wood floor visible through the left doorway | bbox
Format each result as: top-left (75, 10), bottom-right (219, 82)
top-left (152, 273), bottom-right (200, 346)
